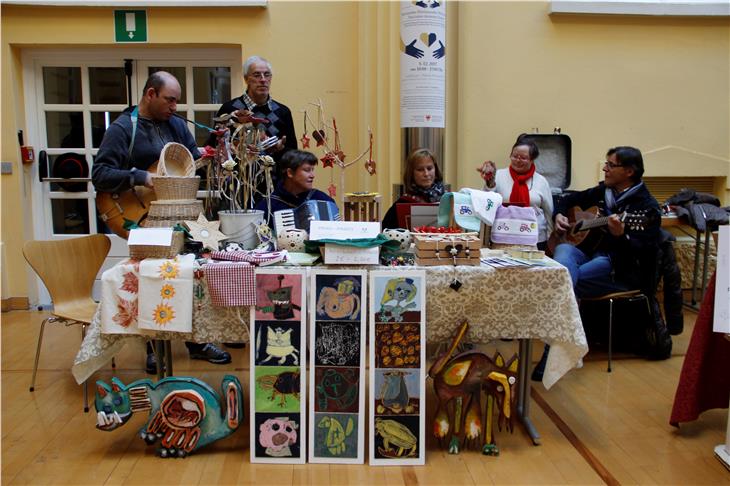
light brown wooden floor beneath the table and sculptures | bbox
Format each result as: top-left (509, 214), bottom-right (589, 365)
top-left (1, 311), bottom-right (730, 485)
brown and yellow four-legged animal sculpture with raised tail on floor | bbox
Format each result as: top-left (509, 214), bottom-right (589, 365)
top-left (428, 322), bottom-right (517, 455)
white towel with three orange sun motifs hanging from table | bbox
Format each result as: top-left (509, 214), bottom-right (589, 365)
top-left (139, 253), bottom-right (195, 332)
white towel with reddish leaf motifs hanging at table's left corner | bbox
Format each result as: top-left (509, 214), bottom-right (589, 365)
top-left (101, 260), bottom-right (139, 334)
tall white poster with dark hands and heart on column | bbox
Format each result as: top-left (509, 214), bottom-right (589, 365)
top-left (400, 0), bottom-right (446, 128)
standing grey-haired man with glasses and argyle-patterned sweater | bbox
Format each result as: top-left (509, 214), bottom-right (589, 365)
top-left (216, 56), bottom-right (297, 165)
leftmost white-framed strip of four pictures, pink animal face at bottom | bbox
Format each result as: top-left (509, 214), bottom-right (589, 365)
top-left (249, 268), bottom-right (307, 464)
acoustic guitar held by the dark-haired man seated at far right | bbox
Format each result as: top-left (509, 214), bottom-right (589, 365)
top-left (547, 206), bottom-right (647, 256)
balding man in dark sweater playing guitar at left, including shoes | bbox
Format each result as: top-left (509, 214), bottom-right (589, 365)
top-left (91, 71), bottom-right (231, 373)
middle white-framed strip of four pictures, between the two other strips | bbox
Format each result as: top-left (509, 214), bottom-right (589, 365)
top-left (309, 270), bottom-right (367, 464)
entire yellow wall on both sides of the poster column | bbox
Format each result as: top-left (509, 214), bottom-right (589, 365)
top-left (0, 1), bottom-right (730, 297)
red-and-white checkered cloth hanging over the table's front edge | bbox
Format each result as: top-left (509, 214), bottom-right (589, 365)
top-left (203, 260), bottom-right (256, 307)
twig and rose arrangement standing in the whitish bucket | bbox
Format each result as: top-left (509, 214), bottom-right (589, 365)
top-left (208, 115), bottom-right (274, 211)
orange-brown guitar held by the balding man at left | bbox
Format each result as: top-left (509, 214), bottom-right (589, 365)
top-left (96, 158), bottom-right (210, 240)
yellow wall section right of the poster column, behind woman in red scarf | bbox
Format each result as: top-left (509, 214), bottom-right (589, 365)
top-left (451, 2), bottom-right (730, 194)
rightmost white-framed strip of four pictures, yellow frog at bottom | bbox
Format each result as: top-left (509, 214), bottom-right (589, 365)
top-left (369, 270), bottom-right (426, 466)
